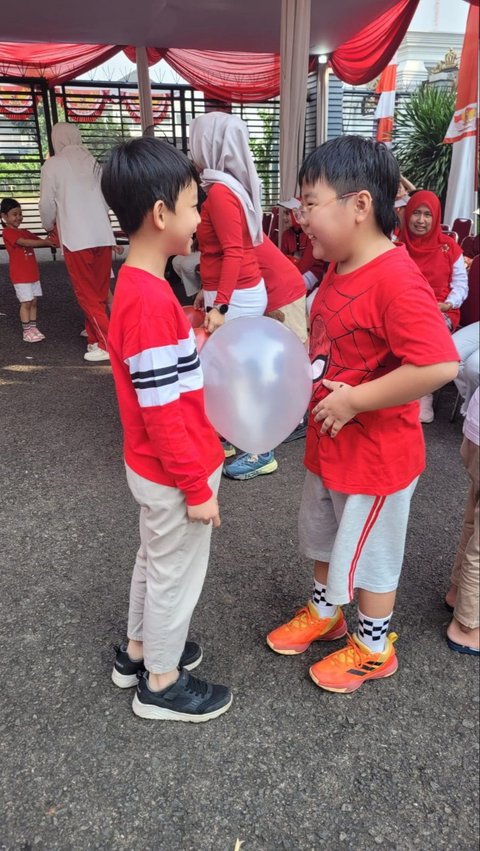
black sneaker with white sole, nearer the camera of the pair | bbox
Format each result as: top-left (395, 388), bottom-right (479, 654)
top-left (132, 668), bottom-right (232, 724)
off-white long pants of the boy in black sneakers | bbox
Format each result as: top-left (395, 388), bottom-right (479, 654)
top-left (126, 466), bottom-right (222, 674)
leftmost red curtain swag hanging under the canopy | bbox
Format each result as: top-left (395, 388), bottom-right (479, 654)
top-left (0, 42), bottom-right (120, 86)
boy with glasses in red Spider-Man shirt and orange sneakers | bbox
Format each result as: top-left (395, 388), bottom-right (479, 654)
top-left (267, 136), bottom-right (458, 692)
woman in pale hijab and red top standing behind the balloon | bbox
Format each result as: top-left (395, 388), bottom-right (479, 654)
top-left (190, 112), bottom-right (267, 332)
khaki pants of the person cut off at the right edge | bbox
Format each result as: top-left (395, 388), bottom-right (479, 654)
top-left (451, 438), bottom-right (480, 629)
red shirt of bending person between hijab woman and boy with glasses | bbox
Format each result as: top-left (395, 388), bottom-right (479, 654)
top-left (255, 236), bottom-right (306, 313)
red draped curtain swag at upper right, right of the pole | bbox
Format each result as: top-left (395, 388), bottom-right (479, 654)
top-left (330, 0), bottom-right (419, 86)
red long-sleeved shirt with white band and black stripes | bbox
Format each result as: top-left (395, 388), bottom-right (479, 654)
top-left (108, 266), bottom-right (224, 505)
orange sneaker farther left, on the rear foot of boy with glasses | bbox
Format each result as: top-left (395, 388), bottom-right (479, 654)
top-left (267, 600), bottom-right (347, 656)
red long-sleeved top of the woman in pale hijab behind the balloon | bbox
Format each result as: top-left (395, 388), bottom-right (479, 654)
top-left (197, 183), bottom-right (261, 304)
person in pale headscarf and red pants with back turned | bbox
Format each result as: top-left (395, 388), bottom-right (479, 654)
top-left (40, 122), bottom-right (115, 361)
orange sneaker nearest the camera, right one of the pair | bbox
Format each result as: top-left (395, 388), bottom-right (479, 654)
top-left (310, 632), bottom-right (398, 692)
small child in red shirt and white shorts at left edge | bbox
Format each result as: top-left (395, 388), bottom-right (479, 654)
top-left (0, 198), bottom-right (55, 343)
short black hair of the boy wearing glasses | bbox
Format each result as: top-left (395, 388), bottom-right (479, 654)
top-left (298, 136), bottom-right (400, 236)
